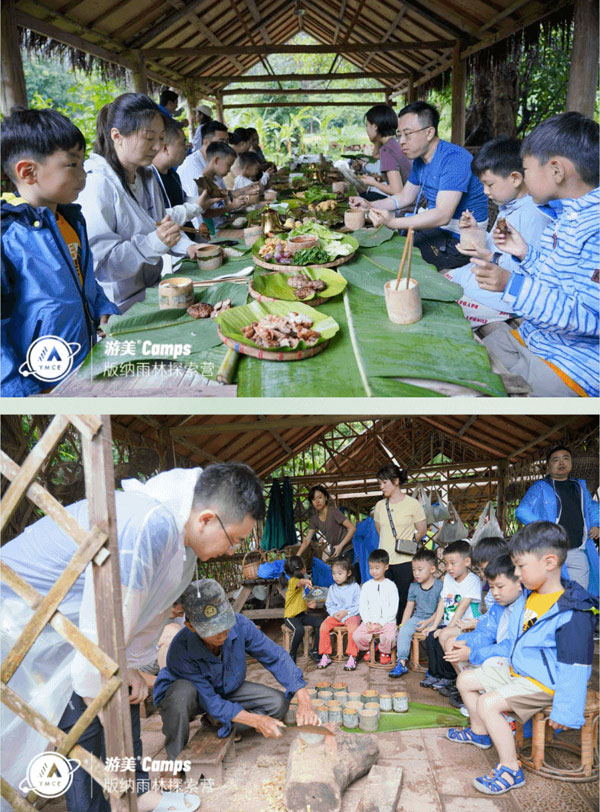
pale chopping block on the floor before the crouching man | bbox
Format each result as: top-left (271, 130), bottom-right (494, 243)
top-left (284, 727), bottom-right (379, 812)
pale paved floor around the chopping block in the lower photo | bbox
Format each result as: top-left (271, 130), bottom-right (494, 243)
top-left (37, 627), bottom-right (598, 812)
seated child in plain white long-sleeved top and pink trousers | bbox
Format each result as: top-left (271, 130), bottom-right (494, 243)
top-left (352, 550), bottom-right (399, 665)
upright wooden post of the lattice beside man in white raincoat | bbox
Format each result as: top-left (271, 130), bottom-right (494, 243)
top-left (81, 415), bottom-right (137, 812)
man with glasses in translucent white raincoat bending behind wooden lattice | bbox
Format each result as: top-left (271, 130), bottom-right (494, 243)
top-left (1, 463), bottom-right (265, 812)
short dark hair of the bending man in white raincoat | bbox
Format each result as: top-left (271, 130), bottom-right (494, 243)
top-left (193, 462), bottom-right (265, 522)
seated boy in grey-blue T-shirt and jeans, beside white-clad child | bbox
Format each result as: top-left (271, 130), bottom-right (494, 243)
top-left (388, 548), bottom-right (442, 679)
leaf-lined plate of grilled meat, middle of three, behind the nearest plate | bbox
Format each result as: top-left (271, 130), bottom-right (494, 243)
top-left (250, 266), bottom-right (347, 307)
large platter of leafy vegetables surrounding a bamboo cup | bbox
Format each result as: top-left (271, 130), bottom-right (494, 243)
top-left (252, 222), bottom-right (359, 271)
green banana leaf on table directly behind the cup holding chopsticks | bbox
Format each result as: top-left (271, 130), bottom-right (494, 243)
top-left (339, 236), bottom-right (463, 302)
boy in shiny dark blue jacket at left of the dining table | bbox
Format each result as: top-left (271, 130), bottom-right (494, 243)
top-left (1, 110), bottom-right (119, 397)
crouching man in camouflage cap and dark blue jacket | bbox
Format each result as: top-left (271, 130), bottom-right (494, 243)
top-left (154, 579), bottom-right (319, 772)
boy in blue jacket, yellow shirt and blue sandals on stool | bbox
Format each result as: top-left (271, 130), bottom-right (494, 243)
top-left (447, 522), bottom-right (598, 795)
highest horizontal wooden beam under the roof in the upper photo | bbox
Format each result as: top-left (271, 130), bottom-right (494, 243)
top-left (144, 40), bottom-right (454, 59)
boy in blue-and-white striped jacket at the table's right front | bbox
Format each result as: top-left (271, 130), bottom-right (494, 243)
top-left (472, 112), bottom-right (600, 397)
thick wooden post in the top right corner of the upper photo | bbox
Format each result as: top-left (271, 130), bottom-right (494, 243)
top-left (567, 0), bottom-right (598, 118)
